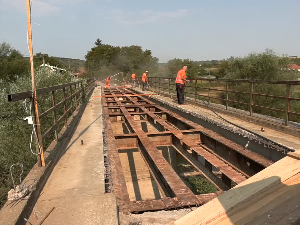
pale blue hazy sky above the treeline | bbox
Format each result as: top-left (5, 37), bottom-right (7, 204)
top-left (0, 0), bottom-right (300, 62)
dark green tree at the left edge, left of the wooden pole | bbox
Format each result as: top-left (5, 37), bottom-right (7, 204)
top-left (0, 42), bottom-right (30, 81)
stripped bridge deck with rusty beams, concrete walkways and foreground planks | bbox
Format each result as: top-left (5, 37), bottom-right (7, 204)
top-left (0, 78), bottom-right (300, 225)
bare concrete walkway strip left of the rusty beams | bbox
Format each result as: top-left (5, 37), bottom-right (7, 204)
top-left (29, 88), bottom-right (118, 225)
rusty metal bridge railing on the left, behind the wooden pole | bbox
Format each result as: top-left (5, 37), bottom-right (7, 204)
top-left (8, 79), bottom-right (95, 162)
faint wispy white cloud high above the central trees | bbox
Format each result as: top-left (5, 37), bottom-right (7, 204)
top-left (108, 9), bottom-right (188, 26)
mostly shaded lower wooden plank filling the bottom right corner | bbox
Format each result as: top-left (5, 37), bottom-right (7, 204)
top-left (209, 174), bottom-right (300, 225)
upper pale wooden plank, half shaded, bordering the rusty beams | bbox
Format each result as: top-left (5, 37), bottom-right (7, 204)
top-left (174, 151), bottom-right (300, 225)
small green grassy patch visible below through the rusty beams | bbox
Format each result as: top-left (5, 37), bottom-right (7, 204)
top-left (185, 176), bottom-right (218, 195)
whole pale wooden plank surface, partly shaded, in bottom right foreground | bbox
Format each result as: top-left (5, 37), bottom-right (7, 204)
top-left (173, 150), bottom-right (300, 225)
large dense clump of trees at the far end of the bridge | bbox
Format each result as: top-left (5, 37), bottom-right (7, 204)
top-left (85, 39), bottom-right (158, 79)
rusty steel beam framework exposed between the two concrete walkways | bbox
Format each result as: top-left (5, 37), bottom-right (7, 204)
top-left (102, 88), bottom-right (273, 212)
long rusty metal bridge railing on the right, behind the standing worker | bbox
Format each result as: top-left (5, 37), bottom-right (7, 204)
top-left (143, 77), bottom-right (300, 126)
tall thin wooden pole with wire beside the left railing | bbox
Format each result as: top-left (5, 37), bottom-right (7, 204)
top-left (26, 0), bottom-right (45, 167)
